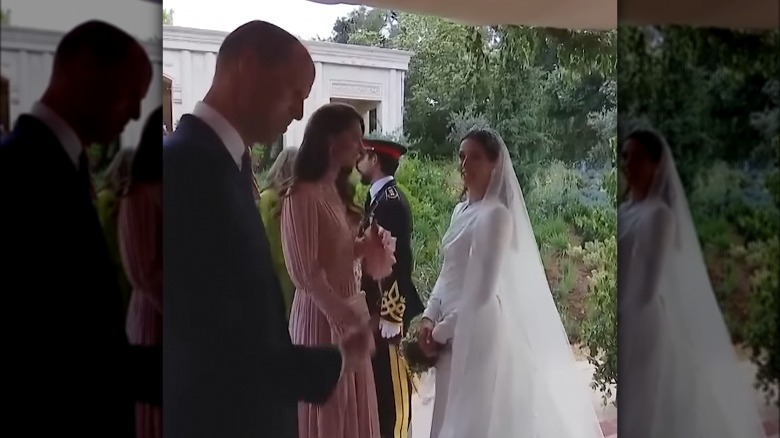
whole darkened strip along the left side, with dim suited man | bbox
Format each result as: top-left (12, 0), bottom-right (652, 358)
top-left (0, 0), bottom-right (163, 438)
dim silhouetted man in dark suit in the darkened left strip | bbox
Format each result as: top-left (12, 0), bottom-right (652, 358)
top-left (0, 21), bottom-right (162, 438)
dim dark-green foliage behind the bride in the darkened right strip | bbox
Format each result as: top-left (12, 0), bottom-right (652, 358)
top-left (618, 26), bottom-right (780, 403)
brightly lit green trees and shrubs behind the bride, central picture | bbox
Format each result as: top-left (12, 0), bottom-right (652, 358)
top-left (306, 8), bottom-right (628, 396)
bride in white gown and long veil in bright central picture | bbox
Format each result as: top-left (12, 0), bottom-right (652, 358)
top-left (420, 130), bottom-right (603, 438)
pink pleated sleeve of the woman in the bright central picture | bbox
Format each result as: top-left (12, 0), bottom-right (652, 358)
top-left (282, 187), bottom-right (356, 321)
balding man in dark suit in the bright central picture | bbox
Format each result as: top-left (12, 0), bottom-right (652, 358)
top-left (163, 21), bottom-right (368, 438)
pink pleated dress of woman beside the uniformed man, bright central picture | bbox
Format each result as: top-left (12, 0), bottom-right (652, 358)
top-left (282, 183), bottom-right (379, 438)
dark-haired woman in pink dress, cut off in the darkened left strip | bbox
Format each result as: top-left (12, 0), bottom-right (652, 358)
top-left (119, 108), bottom-right (162, 438)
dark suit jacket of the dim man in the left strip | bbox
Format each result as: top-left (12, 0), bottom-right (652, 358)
top-left (0, 115), bottom-right (162, 438)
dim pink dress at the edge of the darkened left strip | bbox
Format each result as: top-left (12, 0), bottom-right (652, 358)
top-left (119, 184), bottom-right (162, 438)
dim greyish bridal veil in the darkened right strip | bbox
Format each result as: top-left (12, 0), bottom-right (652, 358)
top-left (618, 131), bottom-right (765, 438)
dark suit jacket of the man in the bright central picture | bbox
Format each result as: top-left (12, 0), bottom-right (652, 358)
top-left (163, 115), bottom-right (341, 438)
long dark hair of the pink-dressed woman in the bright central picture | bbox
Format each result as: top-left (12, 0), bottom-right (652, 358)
top-left (293, 102), bottom-right (366, 216)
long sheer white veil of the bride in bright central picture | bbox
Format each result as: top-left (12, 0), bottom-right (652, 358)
top-left (439, 131), bottom-right (603, 438)
